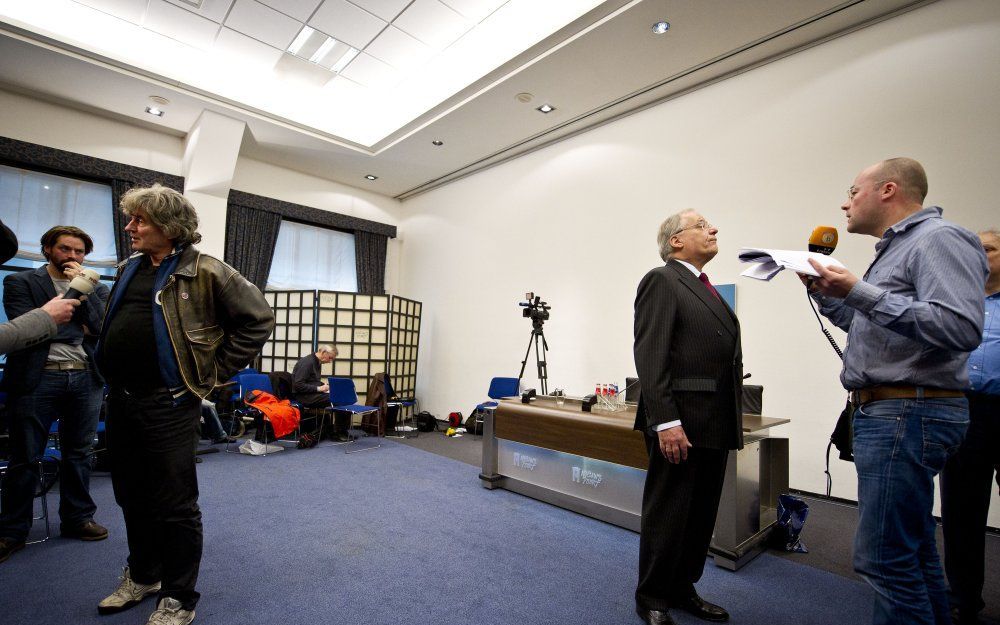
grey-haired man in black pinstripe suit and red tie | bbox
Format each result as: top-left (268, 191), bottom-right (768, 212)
top-left (635, 210), bottom-right (743, 625)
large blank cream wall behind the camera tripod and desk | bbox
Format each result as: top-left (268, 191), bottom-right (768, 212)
top-left (400, 0), bottom-right (1000, 526)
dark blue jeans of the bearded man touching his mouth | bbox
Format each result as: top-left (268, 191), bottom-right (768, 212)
top-left (0, 371), bottom-right (104, 540)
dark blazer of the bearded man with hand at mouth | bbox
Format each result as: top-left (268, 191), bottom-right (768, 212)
top-left (0, 265), bottom-right (110, 395)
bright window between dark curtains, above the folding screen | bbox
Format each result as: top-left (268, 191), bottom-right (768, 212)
top-left (267, 220), bottom-right (358, 293)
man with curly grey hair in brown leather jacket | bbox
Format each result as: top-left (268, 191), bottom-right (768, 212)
top-left (97, 185), bottom-right (274, 625)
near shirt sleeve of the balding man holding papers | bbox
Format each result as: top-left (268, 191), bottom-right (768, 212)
top-left (844, 228), bottom-right (989, 352)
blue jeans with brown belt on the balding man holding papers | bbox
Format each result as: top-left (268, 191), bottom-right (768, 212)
top-left (854, 397), bottom-right (969, 625)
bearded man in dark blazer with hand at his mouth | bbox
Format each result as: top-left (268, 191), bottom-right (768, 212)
top-left (0, 226), bottom-right (108, 562)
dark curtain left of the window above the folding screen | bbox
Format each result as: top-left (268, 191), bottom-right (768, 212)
top-left (225, 204), bottom-right (281, 291)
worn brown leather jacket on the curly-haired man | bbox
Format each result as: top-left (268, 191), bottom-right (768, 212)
top-left (98, 245), bottom-right (274, 398)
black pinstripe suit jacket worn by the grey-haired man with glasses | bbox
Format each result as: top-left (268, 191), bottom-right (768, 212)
top-left (635, 260), bottom-right (743, 449)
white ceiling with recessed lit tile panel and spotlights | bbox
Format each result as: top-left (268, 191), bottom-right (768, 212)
top-left (0, 0), bottom-right (928, 198)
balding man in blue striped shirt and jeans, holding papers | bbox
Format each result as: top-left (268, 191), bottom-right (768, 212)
top-left (810, 158), bottom-right (988, 625)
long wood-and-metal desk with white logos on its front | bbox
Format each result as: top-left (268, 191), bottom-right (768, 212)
top-left (479, 397), bottom-right (788, 570)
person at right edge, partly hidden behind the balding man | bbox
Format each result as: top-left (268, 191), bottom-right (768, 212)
top-left (941, 230), bottom-right (1000, 625)
